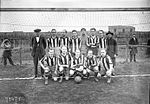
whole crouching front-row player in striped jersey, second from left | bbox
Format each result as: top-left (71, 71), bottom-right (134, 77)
top-left (58, 46), bottom-right (71, 82)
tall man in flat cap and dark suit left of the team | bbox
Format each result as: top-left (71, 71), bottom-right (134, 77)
top-left (31, 29), bottom-right (46, 78)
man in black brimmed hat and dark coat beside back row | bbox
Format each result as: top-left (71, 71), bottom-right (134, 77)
top-left (106, 31), bottom-right (118, 67)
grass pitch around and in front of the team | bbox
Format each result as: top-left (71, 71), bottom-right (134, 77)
top-left (0, 46), bottom-right (150, 104)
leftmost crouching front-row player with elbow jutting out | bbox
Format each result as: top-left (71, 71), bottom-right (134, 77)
top-left (39, 49), bottom-right (57, 84)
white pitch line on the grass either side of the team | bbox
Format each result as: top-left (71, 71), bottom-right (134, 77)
top-left (0, 74), bottom-right (150, 81)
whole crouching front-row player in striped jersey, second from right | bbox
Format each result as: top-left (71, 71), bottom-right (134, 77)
top-left (84, 50), bottom-right (100, 81)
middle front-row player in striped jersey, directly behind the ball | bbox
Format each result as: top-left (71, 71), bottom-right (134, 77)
top-left (70, 50), bottom-right (86, 77)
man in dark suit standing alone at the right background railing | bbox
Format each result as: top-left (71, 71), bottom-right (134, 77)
top-left (129, 34), bottom-right (139, 62)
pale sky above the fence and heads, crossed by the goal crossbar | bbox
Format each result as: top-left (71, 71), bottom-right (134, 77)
top-left (0, 0), bottom-right (150, 32)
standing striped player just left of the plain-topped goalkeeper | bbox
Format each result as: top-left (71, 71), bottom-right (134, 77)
top-left (70, 30), bottom-right (81, 54)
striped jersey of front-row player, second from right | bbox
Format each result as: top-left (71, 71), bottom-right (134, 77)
top-left (84, 55), bottom-right (97, 67)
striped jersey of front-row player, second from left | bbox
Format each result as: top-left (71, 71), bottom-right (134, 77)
top-left (58, 53), bottom-right (71, 65)
